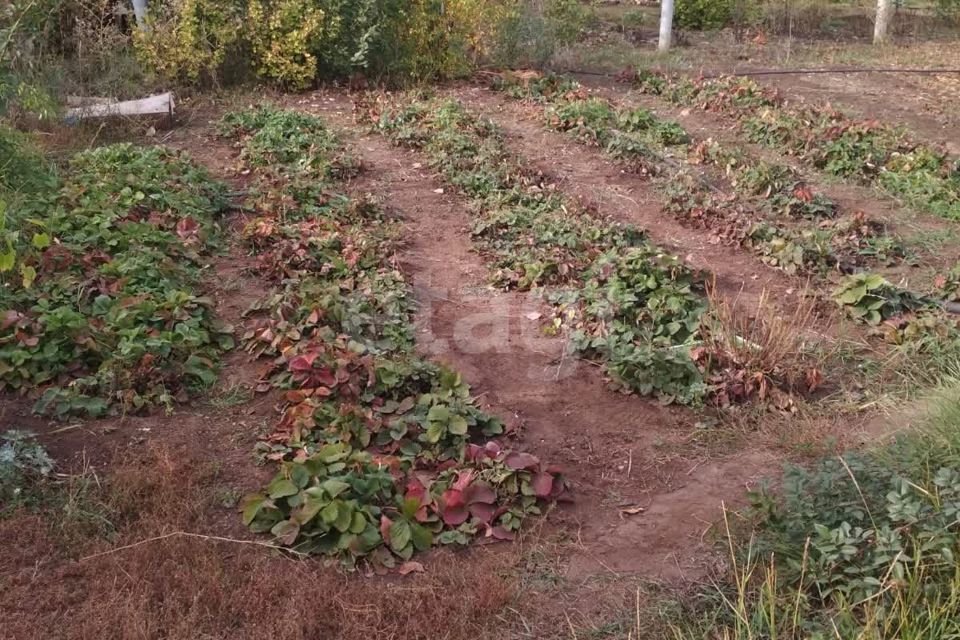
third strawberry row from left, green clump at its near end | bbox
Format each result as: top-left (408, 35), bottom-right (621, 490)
top-left (358, 91), bottom-right (752, 404)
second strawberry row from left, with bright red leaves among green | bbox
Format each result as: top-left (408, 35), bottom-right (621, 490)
top-left (221, 107), bottom-right (565, 567)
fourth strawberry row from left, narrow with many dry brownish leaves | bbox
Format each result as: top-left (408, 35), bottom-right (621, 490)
top-left (495, 75), bottom-right (904, 273)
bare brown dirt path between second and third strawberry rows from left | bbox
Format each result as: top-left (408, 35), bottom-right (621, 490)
top-left (293, 93), bottom-right (773, 579)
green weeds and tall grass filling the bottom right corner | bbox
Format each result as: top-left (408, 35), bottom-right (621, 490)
top-left (675, 384), bottom-right (960, 639)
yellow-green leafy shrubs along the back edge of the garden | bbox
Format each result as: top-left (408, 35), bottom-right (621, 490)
top-left (129, 0), bottom-right (591, 89)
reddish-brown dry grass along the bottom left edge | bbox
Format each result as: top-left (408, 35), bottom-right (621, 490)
top-left (0, 448), bottom-right (514, 640)
